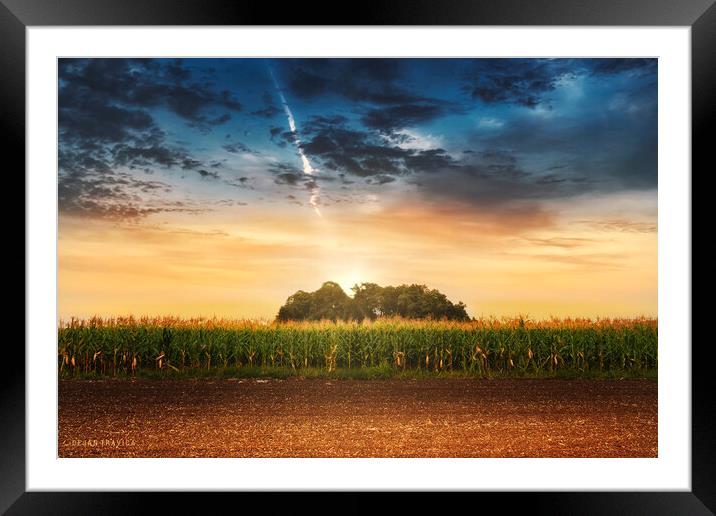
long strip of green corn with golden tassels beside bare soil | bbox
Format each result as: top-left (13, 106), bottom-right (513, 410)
top-left (58, 317), bottom-right (658, 378)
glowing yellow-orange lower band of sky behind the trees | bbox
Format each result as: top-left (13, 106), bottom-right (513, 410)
top-left (58, 189), bottom-right (657, 318)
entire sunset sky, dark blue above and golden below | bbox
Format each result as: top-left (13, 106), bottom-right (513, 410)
top-left (58, 58), bottom-right (657, 319)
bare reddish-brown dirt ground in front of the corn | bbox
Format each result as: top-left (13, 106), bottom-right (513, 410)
top-left (59, 378), bottom-right (657, 457)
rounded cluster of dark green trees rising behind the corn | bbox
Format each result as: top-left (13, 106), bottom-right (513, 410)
top-left (276, 281), bottom-right (469, 321)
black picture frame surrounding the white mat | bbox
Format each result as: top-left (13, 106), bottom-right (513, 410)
top-left (0, 0), bottom-right (716, 515)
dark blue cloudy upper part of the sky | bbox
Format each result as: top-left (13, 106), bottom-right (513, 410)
top-left (58, 58), bottom-right (657, 216)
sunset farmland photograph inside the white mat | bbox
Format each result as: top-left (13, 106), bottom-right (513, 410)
top-left (58, 57), bottom-right (656, 462)
